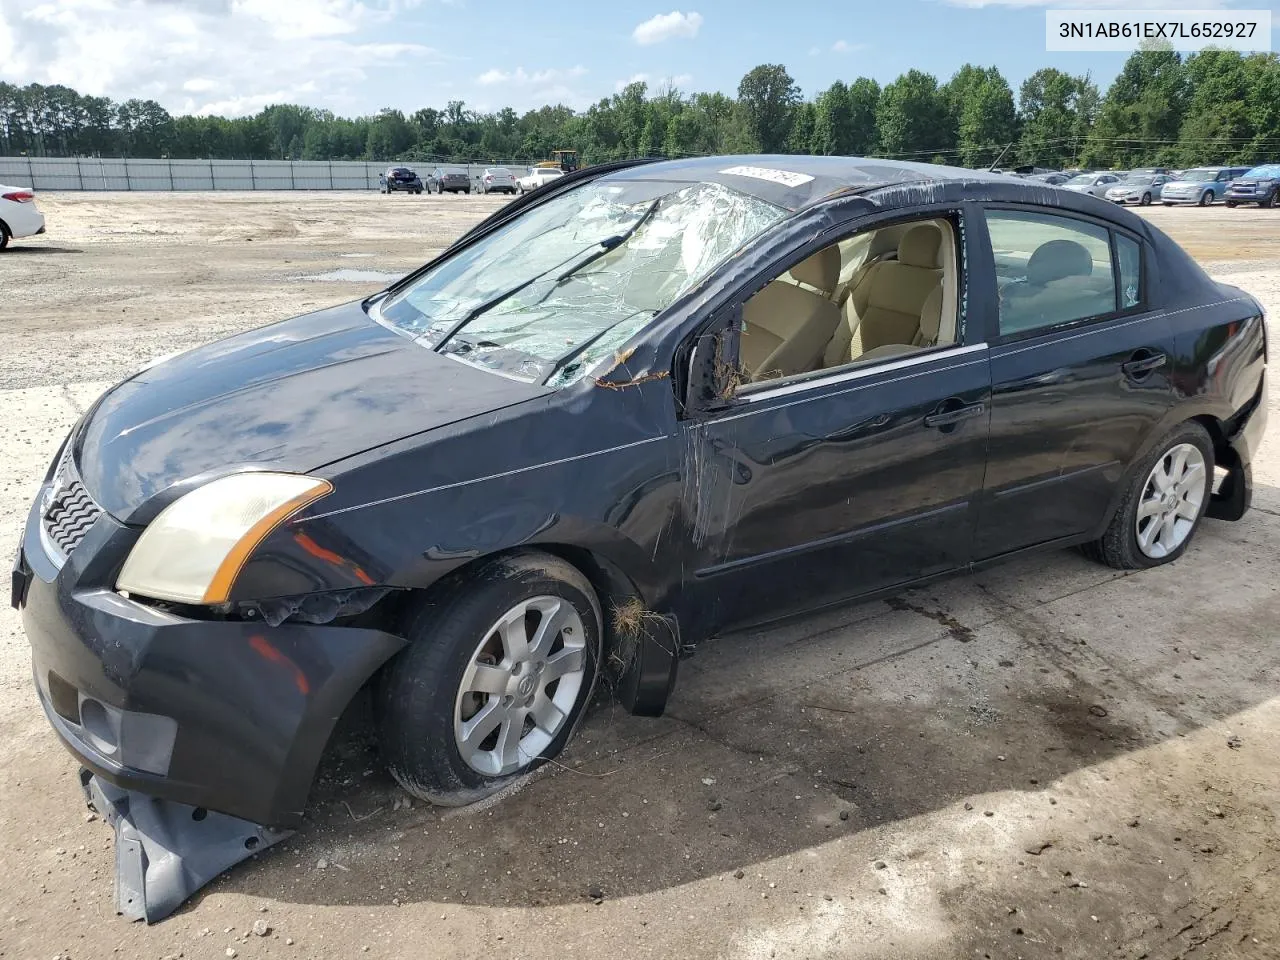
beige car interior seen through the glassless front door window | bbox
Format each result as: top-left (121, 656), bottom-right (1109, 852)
top-left (740, 218), bottom-right (959, 385)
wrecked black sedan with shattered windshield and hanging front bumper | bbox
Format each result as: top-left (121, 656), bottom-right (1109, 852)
top-left (13, 156), bottom-right (1266, 919)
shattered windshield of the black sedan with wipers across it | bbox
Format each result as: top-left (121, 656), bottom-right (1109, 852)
top-left (372, 180), bottom-right (786, 387)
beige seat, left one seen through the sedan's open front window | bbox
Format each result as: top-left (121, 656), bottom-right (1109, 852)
top-left (741, 246), bottom-right (840, 380)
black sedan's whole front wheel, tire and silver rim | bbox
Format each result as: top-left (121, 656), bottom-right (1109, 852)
top-left (374, 552), bottom-right (602, 806)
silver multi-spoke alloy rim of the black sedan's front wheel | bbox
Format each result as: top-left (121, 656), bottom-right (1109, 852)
top-left (453, 596), bottom-right (588, 777)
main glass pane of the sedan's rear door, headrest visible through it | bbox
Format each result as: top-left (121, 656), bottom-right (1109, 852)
top-left (987, 210), bottom-right (1116, 335)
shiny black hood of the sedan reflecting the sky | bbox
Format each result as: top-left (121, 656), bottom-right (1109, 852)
top-left (76, 302), bottom-right (548, 522)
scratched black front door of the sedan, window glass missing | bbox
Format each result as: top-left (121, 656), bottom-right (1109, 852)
top-left (682, 209), bottom-right (991, 628)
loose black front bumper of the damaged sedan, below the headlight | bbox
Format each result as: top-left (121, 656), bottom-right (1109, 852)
top-left (13, 478), bottom-right (404, 828)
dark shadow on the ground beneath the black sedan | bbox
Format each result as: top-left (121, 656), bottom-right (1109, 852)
top-left (209, 504), bottom-right (1280, 909)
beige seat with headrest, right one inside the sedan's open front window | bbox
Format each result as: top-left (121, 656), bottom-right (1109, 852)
top-left (844, 223), bottom-right (942, 362)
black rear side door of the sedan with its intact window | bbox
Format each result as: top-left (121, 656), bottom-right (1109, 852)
top-left (974, 206), bottom-right (1174, 559)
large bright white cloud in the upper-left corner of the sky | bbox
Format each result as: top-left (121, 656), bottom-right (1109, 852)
top-left (0, 0), bottom-right (453, 115)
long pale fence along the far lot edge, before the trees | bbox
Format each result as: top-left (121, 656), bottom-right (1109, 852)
top-left (0, 156), bottom-right (525, 191)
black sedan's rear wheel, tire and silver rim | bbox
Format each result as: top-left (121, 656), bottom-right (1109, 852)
top-left (1083, 420), bottom-right (1213, 570)
